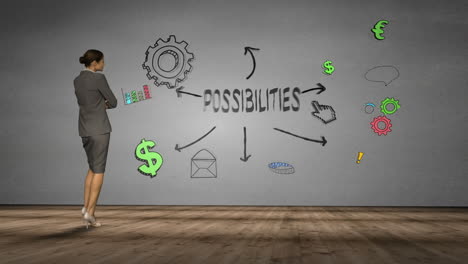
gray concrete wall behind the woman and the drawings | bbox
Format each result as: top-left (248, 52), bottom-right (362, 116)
top-left (0, 0), bottom-right (468, 206)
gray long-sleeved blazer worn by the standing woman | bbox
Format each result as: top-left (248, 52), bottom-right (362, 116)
top-left (73, 70), bottom-right (117, 137)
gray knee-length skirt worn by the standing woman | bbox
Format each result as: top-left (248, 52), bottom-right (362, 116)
top-left (81, 133), bottom-right (110, 173)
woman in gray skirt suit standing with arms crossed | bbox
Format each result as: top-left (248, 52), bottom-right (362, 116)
top-left (73, 49), bottom-right (117, 228)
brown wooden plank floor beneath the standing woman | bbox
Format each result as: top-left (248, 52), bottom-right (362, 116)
top-left (0, 205), bottom-right (468, 264)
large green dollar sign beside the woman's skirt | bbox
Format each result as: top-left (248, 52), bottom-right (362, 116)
top-left (135, 139), bottom-right (163, 178)
